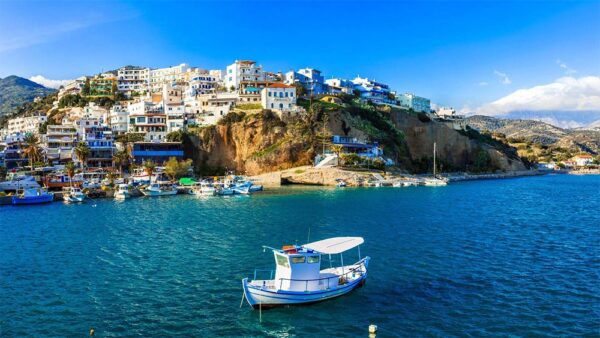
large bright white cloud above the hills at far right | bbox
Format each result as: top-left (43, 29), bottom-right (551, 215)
top-left (477, 76), bottom-right (600, 115)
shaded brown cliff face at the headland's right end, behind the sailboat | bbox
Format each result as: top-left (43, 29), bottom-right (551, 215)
top-left (391, 112), bottom-right (526, 171)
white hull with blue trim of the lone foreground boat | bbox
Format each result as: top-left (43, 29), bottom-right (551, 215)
top-left (242, 273), bottom-right (367, 309)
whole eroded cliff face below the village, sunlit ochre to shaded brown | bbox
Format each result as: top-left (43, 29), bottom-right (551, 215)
top-left (186, 110), bottom-right (526, 175)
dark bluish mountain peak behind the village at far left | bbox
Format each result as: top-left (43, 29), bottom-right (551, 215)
top-left (0, 75), bottom-right (55, 116)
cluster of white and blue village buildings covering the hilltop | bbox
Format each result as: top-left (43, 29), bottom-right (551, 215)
top-left (0, 60), bottom-right (450, 169)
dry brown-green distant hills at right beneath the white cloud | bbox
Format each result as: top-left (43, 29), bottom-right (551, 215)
top-left (467, 115), bottom-right (600, 154)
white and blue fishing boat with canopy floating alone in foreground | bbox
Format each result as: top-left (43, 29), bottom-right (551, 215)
top-left (242, 237), bottom-right (370, 308)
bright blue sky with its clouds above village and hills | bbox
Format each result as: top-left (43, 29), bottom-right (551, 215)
top-left (0, 0), bottom-right (600, 124)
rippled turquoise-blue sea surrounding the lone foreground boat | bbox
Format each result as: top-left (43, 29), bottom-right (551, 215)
top-left (0, 175), bottom-right (600, 337)
